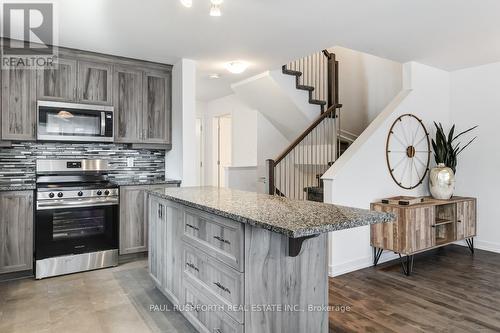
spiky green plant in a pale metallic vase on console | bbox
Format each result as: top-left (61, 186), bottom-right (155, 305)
top-left (429, 122), bottom-right (477, 200)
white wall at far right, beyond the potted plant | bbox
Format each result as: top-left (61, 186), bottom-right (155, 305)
top-left (451, 62), bottom-right (500, 252)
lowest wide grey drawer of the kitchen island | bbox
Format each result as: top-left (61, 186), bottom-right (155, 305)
top-left (183, 281), bottom-right (244, 333)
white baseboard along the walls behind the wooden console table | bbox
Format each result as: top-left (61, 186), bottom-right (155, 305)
top-left (328, 239), bottom-right (500, 277)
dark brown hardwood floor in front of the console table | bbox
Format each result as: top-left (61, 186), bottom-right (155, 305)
top-left (329, 245), bottom-right (500, 333)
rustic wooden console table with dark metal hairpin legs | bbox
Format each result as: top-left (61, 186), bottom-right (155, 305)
top-left (370, 197), bottom-right (476, 275)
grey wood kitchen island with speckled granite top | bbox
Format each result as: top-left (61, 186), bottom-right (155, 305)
top-left (148, 187), bottom-right (393, 333)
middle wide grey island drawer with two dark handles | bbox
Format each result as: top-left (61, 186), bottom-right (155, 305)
top-left (183, 244), bottom-right (244, 323)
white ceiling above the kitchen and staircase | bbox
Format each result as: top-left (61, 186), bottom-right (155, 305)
top-left (45, 0), bottom-right (500, 100)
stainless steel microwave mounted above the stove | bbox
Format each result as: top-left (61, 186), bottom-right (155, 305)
top-left (37, 101), bottom-right (114, 142)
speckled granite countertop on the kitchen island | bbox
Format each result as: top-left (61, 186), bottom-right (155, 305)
top-left (148, 187), bottom-right (394, 238)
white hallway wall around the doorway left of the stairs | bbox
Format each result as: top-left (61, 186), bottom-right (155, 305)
top-left (204, 95), bottom-right (258, 185)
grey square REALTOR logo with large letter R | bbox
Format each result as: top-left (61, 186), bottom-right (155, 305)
top-left (1, 2), bottom-right (57, 69)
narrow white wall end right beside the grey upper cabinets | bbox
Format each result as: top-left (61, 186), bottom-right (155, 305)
top-left (165, 59), bottom-right (197, 186)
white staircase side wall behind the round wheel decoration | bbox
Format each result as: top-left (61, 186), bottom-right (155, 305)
top-left (323, 63), bottom-right (450, 275)
